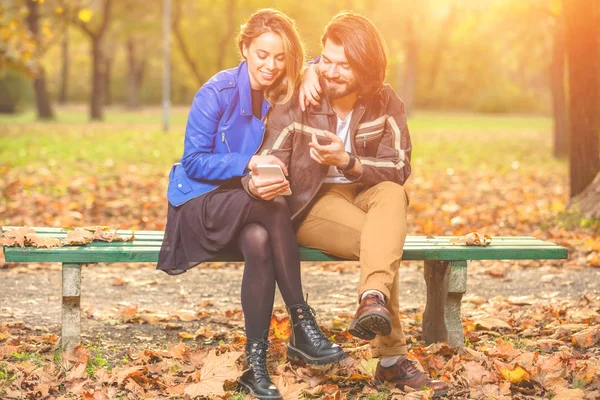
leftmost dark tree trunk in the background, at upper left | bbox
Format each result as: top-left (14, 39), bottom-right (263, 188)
top-left (27, 0), bottom-right (54, 119)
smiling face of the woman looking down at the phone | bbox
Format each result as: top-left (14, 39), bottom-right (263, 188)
top-left (242, 32), bottom-right (285, 90)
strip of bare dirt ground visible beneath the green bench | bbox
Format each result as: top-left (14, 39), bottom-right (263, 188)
top-left (0, 261), bottom-right (600, 358)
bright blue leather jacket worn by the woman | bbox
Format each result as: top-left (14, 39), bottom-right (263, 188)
top-left (167, 61), bottom-right (271, 206)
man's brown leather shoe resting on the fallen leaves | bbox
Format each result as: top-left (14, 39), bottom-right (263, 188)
top-left (375, 356), bottom-right (450, 397)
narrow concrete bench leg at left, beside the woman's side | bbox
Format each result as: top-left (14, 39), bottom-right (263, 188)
top-left (61, 263), bottom-right (82, 354)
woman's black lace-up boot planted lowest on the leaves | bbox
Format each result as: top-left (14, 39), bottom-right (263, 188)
top-left (238, 339), bottom-right (282, 400)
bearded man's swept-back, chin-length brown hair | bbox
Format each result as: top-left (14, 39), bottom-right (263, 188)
top-left (321, 12), bottom-right (387, 95)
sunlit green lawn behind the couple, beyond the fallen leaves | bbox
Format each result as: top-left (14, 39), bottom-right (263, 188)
top-left (0, 107), bottom-right (566, 177)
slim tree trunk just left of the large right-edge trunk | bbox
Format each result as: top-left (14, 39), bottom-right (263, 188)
top-left (549, 16), bottom-right (569, 158)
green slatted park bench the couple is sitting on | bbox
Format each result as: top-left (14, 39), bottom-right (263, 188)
top-left (3, 227), bottom-right (567, 350)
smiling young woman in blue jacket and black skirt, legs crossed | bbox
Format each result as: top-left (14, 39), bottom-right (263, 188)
top-left (157, 9), bottom-right (345, 399)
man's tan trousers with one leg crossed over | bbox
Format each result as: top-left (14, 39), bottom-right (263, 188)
top-left (296, 182), bottom-right (408, 357)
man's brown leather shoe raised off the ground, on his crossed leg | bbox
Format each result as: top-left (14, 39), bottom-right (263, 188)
top-left (348, 293), bottom-right (392, 340)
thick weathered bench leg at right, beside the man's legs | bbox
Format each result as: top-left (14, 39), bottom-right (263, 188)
top-left (423, 261), bottom-right (467, 348)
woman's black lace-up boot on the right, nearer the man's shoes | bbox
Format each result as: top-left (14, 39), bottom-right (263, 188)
top-left (288, 302), bottom-right (346, 365)
